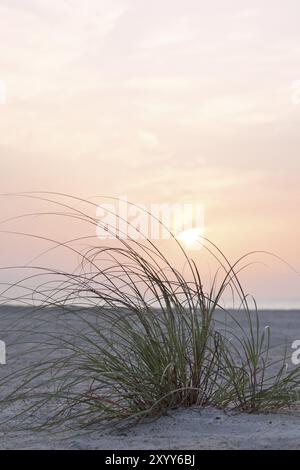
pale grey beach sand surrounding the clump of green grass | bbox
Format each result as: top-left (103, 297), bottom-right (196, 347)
top-left (0, 307), bottom-right (300, 450)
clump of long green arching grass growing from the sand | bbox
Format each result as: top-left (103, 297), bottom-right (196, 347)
top-left (0, 194), bottom-right (300, 424)
